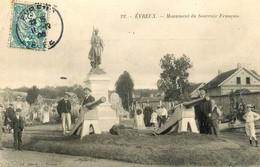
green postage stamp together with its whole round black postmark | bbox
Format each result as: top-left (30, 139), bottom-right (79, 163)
top-left (9, 3), bottom-right (63, 51)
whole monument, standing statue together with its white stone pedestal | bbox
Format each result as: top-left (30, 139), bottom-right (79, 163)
top-left (84, 29), bottom-right (119, 132)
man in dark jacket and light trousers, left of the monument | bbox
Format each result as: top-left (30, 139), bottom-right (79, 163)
top-left (57, 93), bottom-right (71, 134)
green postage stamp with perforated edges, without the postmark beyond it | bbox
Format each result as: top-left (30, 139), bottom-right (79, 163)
top-left (9, 3), bottom-right (50, 51)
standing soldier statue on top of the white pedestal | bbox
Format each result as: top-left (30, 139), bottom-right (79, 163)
top-left (88, 28), bottom-right (104, 72)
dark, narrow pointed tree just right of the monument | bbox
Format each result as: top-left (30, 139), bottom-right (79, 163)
top-left (115, 71), bottom-right (134, 111)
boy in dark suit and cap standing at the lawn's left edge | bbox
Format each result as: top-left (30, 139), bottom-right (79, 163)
top-left (12, 108), bottom-right (24, 150)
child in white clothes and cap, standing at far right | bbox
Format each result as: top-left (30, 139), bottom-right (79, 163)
top-left (243, 104), bottom-right (260, 147)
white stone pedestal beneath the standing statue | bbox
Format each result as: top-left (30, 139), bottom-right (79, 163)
top-left (85, 74), bottom-right (119, 132)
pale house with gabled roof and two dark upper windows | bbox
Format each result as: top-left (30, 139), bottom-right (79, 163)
top-left (204, 64), bottom-right (260, 96)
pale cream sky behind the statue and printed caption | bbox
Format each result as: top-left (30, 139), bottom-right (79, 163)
top-left (0, 0), bottom-right (260, 89)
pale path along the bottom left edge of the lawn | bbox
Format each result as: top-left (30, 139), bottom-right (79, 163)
top-left (0, 148), bottom-right (150, 167)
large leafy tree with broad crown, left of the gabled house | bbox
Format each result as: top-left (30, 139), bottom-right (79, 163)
top-left (157, 54), bottom-right (192, 101)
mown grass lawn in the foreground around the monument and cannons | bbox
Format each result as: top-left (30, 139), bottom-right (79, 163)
top-left (3, 125), bottom-right (260, 166)
